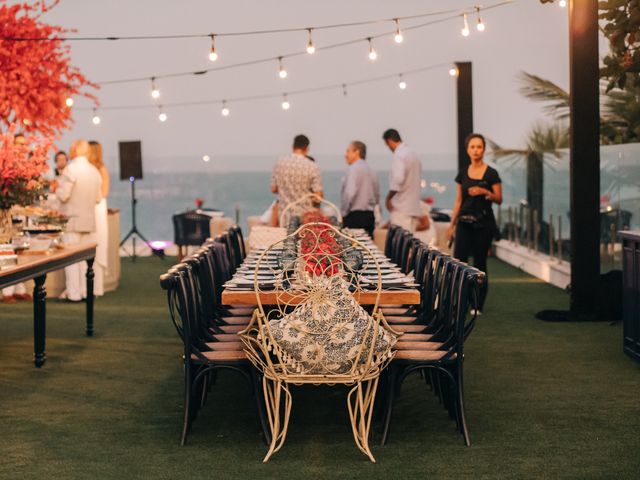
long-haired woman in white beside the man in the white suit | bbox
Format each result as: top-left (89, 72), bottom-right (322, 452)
top-left (89, 141), bottom-right (109, 296)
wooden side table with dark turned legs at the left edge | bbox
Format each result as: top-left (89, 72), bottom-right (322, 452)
top-left (0, 243), bottom-right (96, 368)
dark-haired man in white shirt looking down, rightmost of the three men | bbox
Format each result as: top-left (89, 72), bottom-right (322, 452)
top-left (382, 128), bottom-right (422, 232)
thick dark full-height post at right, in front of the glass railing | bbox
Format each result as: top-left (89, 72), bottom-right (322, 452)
top-left (569, 0), bottom-right (600, 319)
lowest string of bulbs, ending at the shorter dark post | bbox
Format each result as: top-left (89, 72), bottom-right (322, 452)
top-left (78, 62), bottom-right (452, 110)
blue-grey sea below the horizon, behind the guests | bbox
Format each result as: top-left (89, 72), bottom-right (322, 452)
top-left (108, 170), bottom-right (568, 240)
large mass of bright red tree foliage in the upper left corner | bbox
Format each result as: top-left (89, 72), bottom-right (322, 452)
top-left (0, 0), bottom-right (97, 137)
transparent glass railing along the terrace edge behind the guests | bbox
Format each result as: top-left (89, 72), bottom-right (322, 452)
top-left (108, 144), bottom-right (640, 240)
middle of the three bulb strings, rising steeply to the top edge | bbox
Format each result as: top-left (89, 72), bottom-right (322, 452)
top-left (97, 0), bottom-right (515, 86)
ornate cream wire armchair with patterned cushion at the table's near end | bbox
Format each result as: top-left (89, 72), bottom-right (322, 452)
top-left (241, 223), bottom-right (396, 461)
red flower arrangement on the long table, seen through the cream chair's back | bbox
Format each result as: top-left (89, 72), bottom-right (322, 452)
top-left (300, 210), bottom-right (340, 277)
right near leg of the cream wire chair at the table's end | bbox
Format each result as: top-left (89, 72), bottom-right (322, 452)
top-left (347, 378), bottom-right (378, 463)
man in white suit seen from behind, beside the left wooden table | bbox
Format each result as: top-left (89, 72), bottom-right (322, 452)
top-left (56, 140), bottom-right (102, 302)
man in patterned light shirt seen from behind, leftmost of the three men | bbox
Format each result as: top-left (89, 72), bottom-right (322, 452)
top-left (271, 135), bottom-right (322, 228)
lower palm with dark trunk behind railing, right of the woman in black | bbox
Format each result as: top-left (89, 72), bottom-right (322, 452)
top-left (489, 122), bottom-right (569, 227)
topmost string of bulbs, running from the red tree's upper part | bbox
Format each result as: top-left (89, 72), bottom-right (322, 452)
top-left (2, 4), bottom-right (516, 42)
